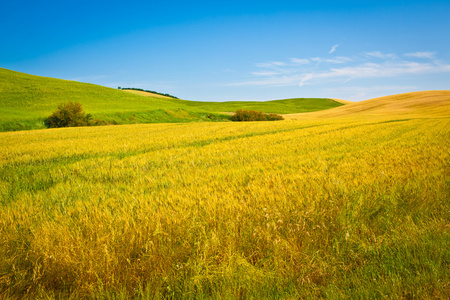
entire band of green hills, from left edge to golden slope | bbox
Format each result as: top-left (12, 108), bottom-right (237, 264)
top-left (0, 68), bottom-right (342, 131)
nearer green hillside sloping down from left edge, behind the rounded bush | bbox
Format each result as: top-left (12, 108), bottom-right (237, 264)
top-left (0, 68), bottom-right (225, 131)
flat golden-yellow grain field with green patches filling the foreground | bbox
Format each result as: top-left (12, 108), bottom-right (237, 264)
top-left (0, 118), bottom-right (450, 299)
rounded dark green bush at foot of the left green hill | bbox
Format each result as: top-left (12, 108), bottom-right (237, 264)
top-left (44, 102), bottom-right (92, 128)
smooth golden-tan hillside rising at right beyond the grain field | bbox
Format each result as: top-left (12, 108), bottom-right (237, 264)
top-left (285, 90), bottom-right (450, 119)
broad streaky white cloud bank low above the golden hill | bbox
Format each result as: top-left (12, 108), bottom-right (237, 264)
top-left (232, 51), bottom-right (450, 86)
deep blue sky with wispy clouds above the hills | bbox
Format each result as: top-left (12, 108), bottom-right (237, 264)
top-left (0, 0), bottom-right (450, 101)
